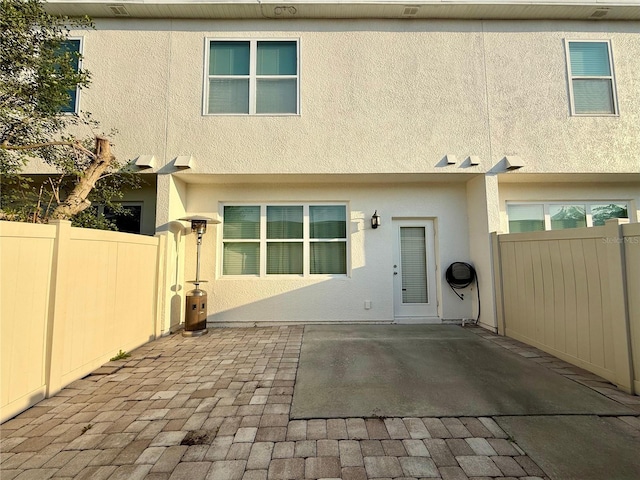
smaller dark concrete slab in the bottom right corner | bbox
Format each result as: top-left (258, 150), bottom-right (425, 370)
top-left (496, 416), bottom-right (640, 480)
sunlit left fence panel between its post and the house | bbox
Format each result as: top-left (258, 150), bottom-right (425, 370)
top-left (61, 228), bottom-right (158, 384)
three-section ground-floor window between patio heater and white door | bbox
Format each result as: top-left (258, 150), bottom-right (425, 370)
top-left (222, 204), bottom-right (347, 276)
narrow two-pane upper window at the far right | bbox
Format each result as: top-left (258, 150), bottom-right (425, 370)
top-left (567, 41), bottom-right (618, 115)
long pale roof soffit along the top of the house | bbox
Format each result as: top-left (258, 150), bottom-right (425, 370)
top-left (46, 0), bottom-right (640, 21)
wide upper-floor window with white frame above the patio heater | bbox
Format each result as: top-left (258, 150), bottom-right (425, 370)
top-left (205, 40), bottom-right (299, 115)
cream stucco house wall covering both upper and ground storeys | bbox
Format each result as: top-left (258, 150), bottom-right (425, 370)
top-left (12, 19), bottom-right (640, 332)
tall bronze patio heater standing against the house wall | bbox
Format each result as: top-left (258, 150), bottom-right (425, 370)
top-left (180, 216), bottom-right (220, 337)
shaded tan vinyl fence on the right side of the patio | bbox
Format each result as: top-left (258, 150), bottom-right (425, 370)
top-left (492, 220), bottom-right (640, 393)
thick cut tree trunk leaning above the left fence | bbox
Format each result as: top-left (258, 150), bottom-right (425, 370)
top-left (51, 137), bottom-right (115, 220)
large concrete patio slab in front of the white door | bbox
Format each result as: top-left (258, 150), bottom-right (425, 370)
top-left (291, 325), bottom-right (634, 419)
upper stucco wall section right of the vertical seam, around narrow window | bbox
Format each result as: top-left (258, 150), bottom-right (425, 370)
top-left (485, 22), bottom-right (640, 173)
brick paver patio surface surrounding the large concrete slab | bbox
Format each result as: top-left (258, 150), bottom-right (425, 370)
top-left (0, 326), bottom-right (640, 480)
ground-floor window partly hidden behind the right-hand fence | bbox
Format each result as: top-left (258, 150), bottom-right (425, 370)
top-left (507, 201), bottom-right (629, 233)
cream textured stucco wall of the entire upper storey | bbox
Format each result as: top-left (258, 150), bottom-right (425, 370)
top-left (66, 19), bottom-right (640, 176)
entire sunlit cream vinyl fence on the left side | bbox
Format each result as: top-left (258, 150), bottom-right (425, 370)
top-left (0, 221), bottom-right (165, 421)
